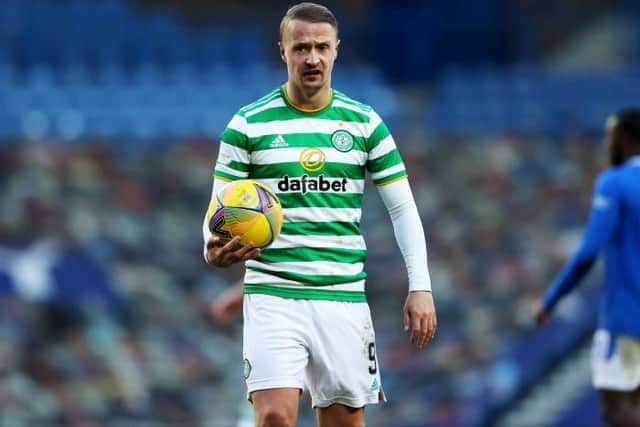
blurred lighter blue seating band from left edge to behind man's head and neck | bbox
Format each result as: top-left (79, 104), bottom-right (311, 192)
top-left (0, 63), bottom-right (398, 140)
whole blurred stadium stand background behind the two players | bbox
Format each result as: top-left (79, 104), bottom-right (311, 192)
top-left (0, 0), bottom-right (640, 427)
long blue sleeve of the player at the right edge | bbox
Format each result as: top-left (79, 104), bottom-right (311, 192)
top-left (543, 171), bottom-right (620, 311)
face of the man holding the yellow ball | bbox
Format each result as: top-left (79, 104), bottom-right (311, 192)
top-left (280, 19), bottom-right (340, 91)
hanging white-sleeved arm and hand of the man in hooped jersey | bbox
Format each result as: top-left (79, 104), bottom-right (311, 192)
top-left (378, 178), bottom-right (437, 348)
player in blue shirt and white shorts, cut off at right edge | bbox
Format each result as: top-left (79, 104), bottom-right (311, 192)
top-left (536, 109), bottom-right (640, 427)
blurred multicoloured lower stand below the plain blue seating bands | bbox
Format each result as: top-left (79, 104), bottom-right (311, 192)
top-left (0, 137), bottom-right (598, 426)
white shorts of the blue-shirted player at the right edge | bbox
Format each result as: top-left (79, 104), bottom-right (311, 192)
top-left (591, 329), bottom-right (640, 391)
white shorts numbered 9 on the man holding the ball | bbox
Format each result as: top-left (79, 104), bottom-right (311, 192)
top-left (243, 294), bottom-right (385, 408)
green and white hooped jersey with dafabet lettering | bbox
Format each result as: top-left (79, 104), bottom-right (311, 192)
top-left (215, 86), bottom-right (406, 302)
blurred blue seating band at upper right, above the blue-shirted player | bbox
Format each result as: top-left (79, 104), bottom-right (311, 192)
top-left (426, 66), bottom-right (640, 134)
